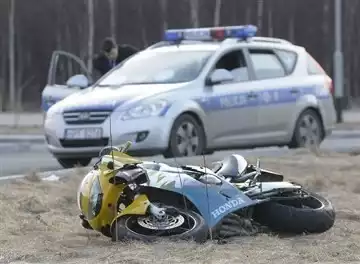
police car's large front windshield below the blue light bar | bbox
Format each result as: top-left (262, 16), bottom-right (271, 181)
top-left (98, 50), bottom-right (212, 86)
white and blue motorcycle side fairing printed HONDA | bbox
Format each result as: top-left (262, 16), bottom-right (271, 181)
top-left (139, 163), bottom-right (262, 228)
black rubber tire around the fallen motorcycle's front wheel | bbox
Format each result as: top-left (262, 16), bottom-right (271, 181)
top-left (111, 206), bottom-right (209, 243)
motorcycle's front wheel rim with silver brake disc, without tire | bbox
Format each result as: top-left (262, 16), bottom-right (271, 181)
top-left (125, 210), bottom-right (198, 237)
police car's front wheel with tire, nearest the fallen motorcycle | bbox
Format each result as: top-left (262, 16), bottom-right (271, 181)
top-left (163, 114), bottom-right (205, 158)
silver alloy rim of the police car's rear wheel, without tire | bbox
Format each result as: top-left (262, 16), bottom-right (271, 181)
top-left (299, 115), bottom-right (321, 147)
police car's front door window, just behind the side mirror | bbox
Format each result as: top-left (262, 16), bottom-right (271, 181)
top-left (214, 50), bottom-right (249, 82)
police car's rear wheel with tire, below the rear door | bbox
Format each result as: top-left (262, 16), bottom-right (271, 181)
top-left (289, 109), bottom-right (324, 148)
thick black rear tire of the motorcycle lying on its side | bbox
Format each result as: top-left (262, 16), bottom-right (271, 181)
top-left (253, 192), bottom-right (335, 234)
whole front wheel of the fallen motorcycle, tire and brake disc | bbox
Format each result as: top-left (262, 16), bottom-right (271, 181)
top-left (111, 206), bottom-right (209, 243)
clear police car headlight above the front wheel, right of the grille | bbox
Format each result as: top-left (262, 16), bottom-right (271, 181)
top-left (121, 100), bottom-right (169, 120)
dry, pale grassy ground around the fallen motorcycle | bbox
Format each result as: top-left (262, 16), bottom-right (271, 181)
top-left (0, 150), bottom-right (360, 264)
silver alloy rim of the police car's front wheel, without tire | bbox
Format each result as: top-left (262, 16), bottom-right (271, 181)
top-left (176, 122), bottom-right (199, 156)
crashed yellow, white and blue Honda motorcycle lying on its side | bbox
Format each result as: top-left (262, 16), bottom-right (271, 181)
top-left (78, 141), bottom-right (335, 243)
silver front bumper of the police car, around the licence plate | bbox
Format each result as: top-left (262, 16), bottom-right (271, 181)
top-left (44, 114), bottom-right (172, 158)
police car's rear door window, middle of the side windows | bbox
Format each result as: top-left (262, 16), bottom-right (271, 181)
top-left (249, 49), bottom-right (286, 80)
